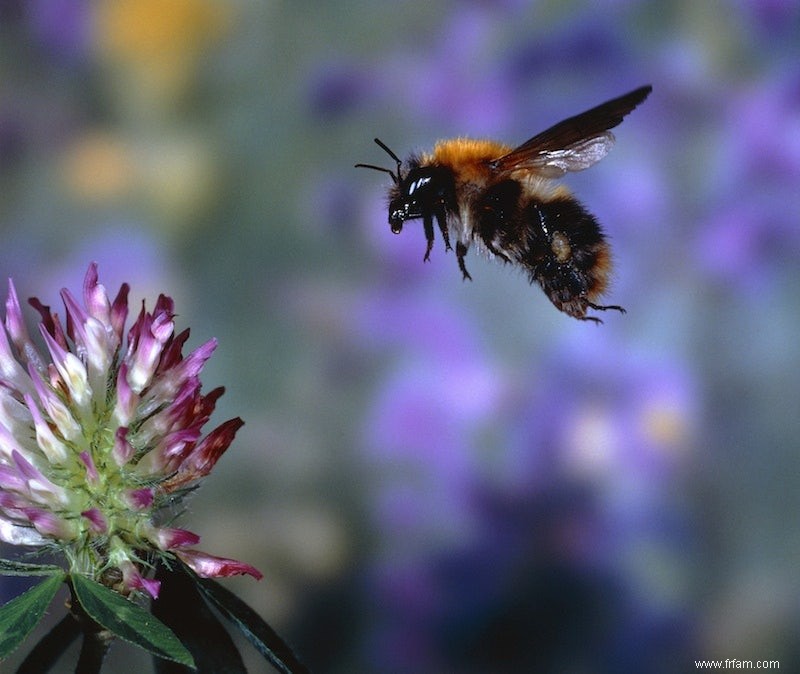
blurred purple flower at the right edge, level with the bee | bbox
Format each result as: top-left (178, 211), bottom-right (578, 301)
top-left (693, 77), bottom-right (800, 289)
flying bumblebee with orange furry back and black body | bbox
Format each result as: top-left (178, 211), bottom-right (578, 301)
top-left (356, 85), bottom-right (652, 323)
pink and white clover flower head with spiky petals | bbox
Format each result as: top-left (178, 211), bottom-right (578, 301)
top-left (0, 264), bottom-right (261, 598)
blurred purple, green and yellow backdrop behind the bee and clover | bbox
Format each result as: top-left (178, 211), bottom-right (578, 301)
top-left (0, 0), bottom-right (800, 674)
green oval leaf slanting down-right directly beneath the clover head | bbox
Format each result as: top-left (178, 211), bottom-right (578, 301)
top-left (71, 574), bottom-right (194, 667)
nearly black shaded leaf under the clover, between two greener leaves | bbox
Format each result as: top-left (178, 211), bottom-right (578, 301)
top-left (153, 565), bottom-right (247, 674)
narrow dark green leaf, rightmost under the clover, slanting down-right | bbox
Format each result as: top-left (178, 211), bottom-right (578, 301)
top-left (187, 570), bottom-right (309, 674)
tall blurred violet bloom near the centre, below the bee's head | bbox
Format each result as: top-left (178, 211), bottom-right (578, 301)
top-left (358, 295), bottom-right (503, 549)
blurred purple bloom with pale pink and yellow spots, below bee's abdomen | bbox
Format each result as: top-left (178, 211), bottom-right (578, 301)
top-left (508, 335), bottom-right (699, 490)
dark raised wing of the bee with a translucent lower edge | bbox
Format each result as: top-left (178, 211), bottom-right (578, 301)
top-left (490, 85), bottom-right (653, 178)
